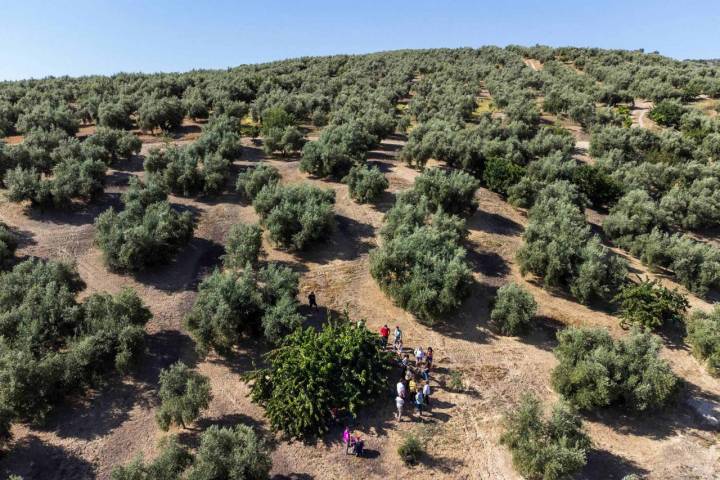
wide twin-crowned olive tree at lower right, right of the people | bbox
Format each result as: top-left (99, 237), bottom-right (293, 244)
top-left (552, 328), bottom-right (678, 411)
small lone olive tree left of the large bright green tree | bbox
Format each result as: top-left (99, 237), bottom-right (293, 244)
top-left (155, 362), bottom-right (212, 431)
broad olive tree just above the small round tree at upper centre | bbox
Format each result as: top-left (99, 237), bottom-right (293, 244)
top-left (300, 121), bottom-right (378, 178)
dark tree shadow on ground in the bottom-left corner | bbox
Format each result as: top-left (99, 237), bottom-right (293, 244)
top-left (0, 435), bottom-right (96, 480)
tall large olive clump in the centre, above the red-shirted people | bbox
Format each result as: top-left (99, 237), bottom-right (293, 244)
top-left (370, 170), bottom-right (477, 324)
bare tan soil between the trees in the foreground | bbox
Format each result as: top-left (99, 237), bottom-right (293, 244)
top-left (0, 132), bottom-right (720, 480)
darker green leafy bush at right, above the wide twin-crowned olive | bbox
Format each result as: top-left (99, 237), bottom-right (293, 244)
top-left (614, 280), bottom-right (690, 330)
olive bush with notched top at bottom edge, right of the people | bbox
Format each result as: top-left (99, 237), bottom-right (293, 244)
top-left (500, 394), bottom-right (591, 480)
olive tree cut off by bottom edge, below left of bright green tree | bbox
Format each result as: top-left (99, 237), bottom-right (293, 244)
top-left (185, 425), bottom-right (272, 480)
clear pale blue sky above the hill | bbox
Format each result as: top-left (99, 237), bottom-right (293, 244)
top-left (0, 0), bottom-right (720, 79)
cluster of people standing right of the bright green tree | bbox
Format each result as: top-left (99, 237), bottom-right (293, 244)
top-left (380, 325), bottom-right (433, 421)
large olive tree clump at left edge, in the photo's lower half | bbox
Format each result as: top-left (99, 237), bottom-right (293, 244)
top-left (0, 260), bottom-right (151, 423)
